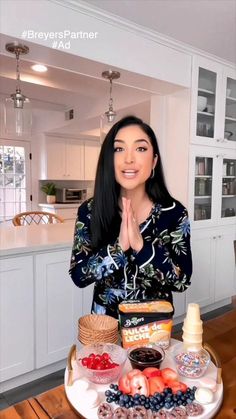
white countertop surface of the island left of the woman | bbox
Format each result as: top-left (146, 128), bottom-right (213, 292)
top-left (0, 221), bottom-right (75, 257)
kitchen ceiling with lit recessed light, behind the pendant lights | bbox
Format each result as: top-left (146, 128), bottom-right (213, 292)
top-left (0, 35), bottom-right (184, 118)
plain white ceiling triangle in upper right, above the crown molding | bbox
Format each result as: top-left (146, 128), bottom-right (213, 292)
top-left (84, 0), bottom-right (236, 63)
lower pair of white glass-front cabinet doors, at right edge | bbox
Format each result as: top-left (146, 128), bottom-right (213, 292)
top-left (189, 146), bottom-right (236, 224)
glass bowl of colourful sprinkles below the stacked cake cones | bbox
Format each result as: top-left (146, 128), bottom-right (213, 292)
top-left (174, 346), bottom-right (211, 379)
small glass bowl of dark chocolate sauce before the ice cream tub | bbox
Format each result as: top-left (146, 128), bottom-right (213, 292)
top-left (128, 344), bottom-right (165, 371)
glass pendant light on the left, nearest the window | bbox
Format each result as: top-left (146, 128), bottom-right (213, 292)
top-left (4, 43), bottom-right (32, 137)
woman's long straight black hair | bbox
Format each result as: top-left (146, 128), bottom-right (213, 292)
top-left (90, 115), bottom-right (173, 249)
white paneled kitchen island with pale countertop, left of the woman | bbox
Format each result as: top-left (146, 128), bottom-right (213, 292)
top-left (0, 222), bottom-right (92, 393)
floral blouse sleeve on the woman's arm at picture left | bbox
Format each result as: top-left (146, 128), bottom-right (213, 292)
top-left (70, 200), bottom-right (126, 288)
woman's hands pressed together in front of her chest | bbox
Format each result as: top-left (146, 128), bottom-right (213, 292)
top-left (119, 197), bottom-right (143, 252)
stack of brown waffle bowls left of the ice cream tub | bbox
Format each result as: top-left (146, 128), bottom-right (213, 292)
top-left (78, 314), bottom-right (119, 345)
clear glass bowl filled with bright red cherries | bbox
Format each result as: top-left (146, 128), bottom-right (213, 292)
top-left (76, 343), bottom-right (127, 384)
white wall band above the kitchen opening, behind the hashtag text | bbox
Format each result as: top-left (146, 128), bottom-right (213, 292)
top-left (0, 0), bottom-right (191, 87)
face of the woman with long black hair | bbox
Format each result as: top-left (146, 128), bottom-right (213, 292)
top-left (114, 125), bottom-right (157, 190)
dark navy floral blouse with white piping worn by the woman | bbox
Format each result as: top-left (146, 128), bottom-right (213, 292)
top-left (70, 199), bottom-right (192, 318)
